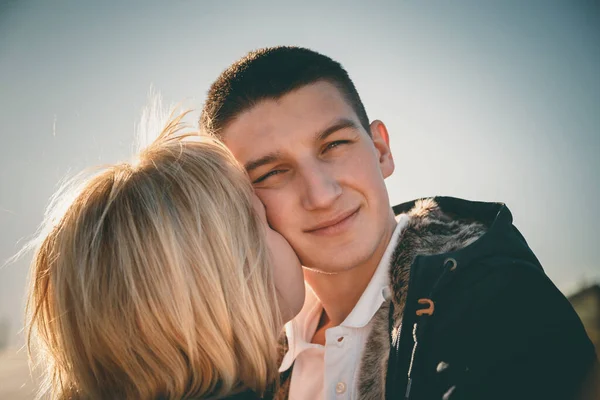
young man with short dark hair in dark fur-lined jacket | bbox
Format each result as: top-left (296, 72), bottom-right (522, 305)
top-left (200, 47), bottom-right (595, 400)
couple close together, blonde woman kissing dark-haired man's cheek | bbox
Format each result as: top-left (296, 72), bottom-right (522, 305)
top-left (28, 47), bottom-right (597, 400)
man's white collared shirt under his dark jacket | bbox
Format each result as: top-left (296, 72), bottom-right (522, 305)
top-left (279, 214), bottom-right (408, 400)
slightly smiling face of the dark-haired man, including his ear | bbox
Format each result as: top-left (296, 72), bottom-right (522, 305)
top-left (223, 82), bottom-right (394, 273)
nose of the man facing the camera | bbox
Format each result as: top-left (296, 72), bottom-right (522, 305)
top-left (302, 163), bottom-right (342, 211)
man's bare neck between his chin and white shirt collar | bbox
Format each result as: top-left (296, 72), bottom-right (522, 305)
top-left (304, 214), bottom-right (396, 344)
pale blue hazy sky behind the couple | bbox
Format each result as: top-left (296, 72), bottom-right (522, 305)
top-left (0, 0), bottom-right (600, 346)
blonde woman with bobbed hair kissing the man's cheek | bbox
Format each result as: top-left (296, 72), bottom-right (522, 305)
top-left (28, 110), bottom-right (304, 399)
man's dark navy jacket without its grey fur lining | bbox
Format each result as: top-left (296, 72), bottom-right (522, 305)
top-left (385, 197), bottom-right (597, 400)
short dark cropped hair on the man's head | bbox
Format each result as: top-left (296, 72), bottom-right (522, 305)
top-left (200, 46), bottom-right (370, 137)
